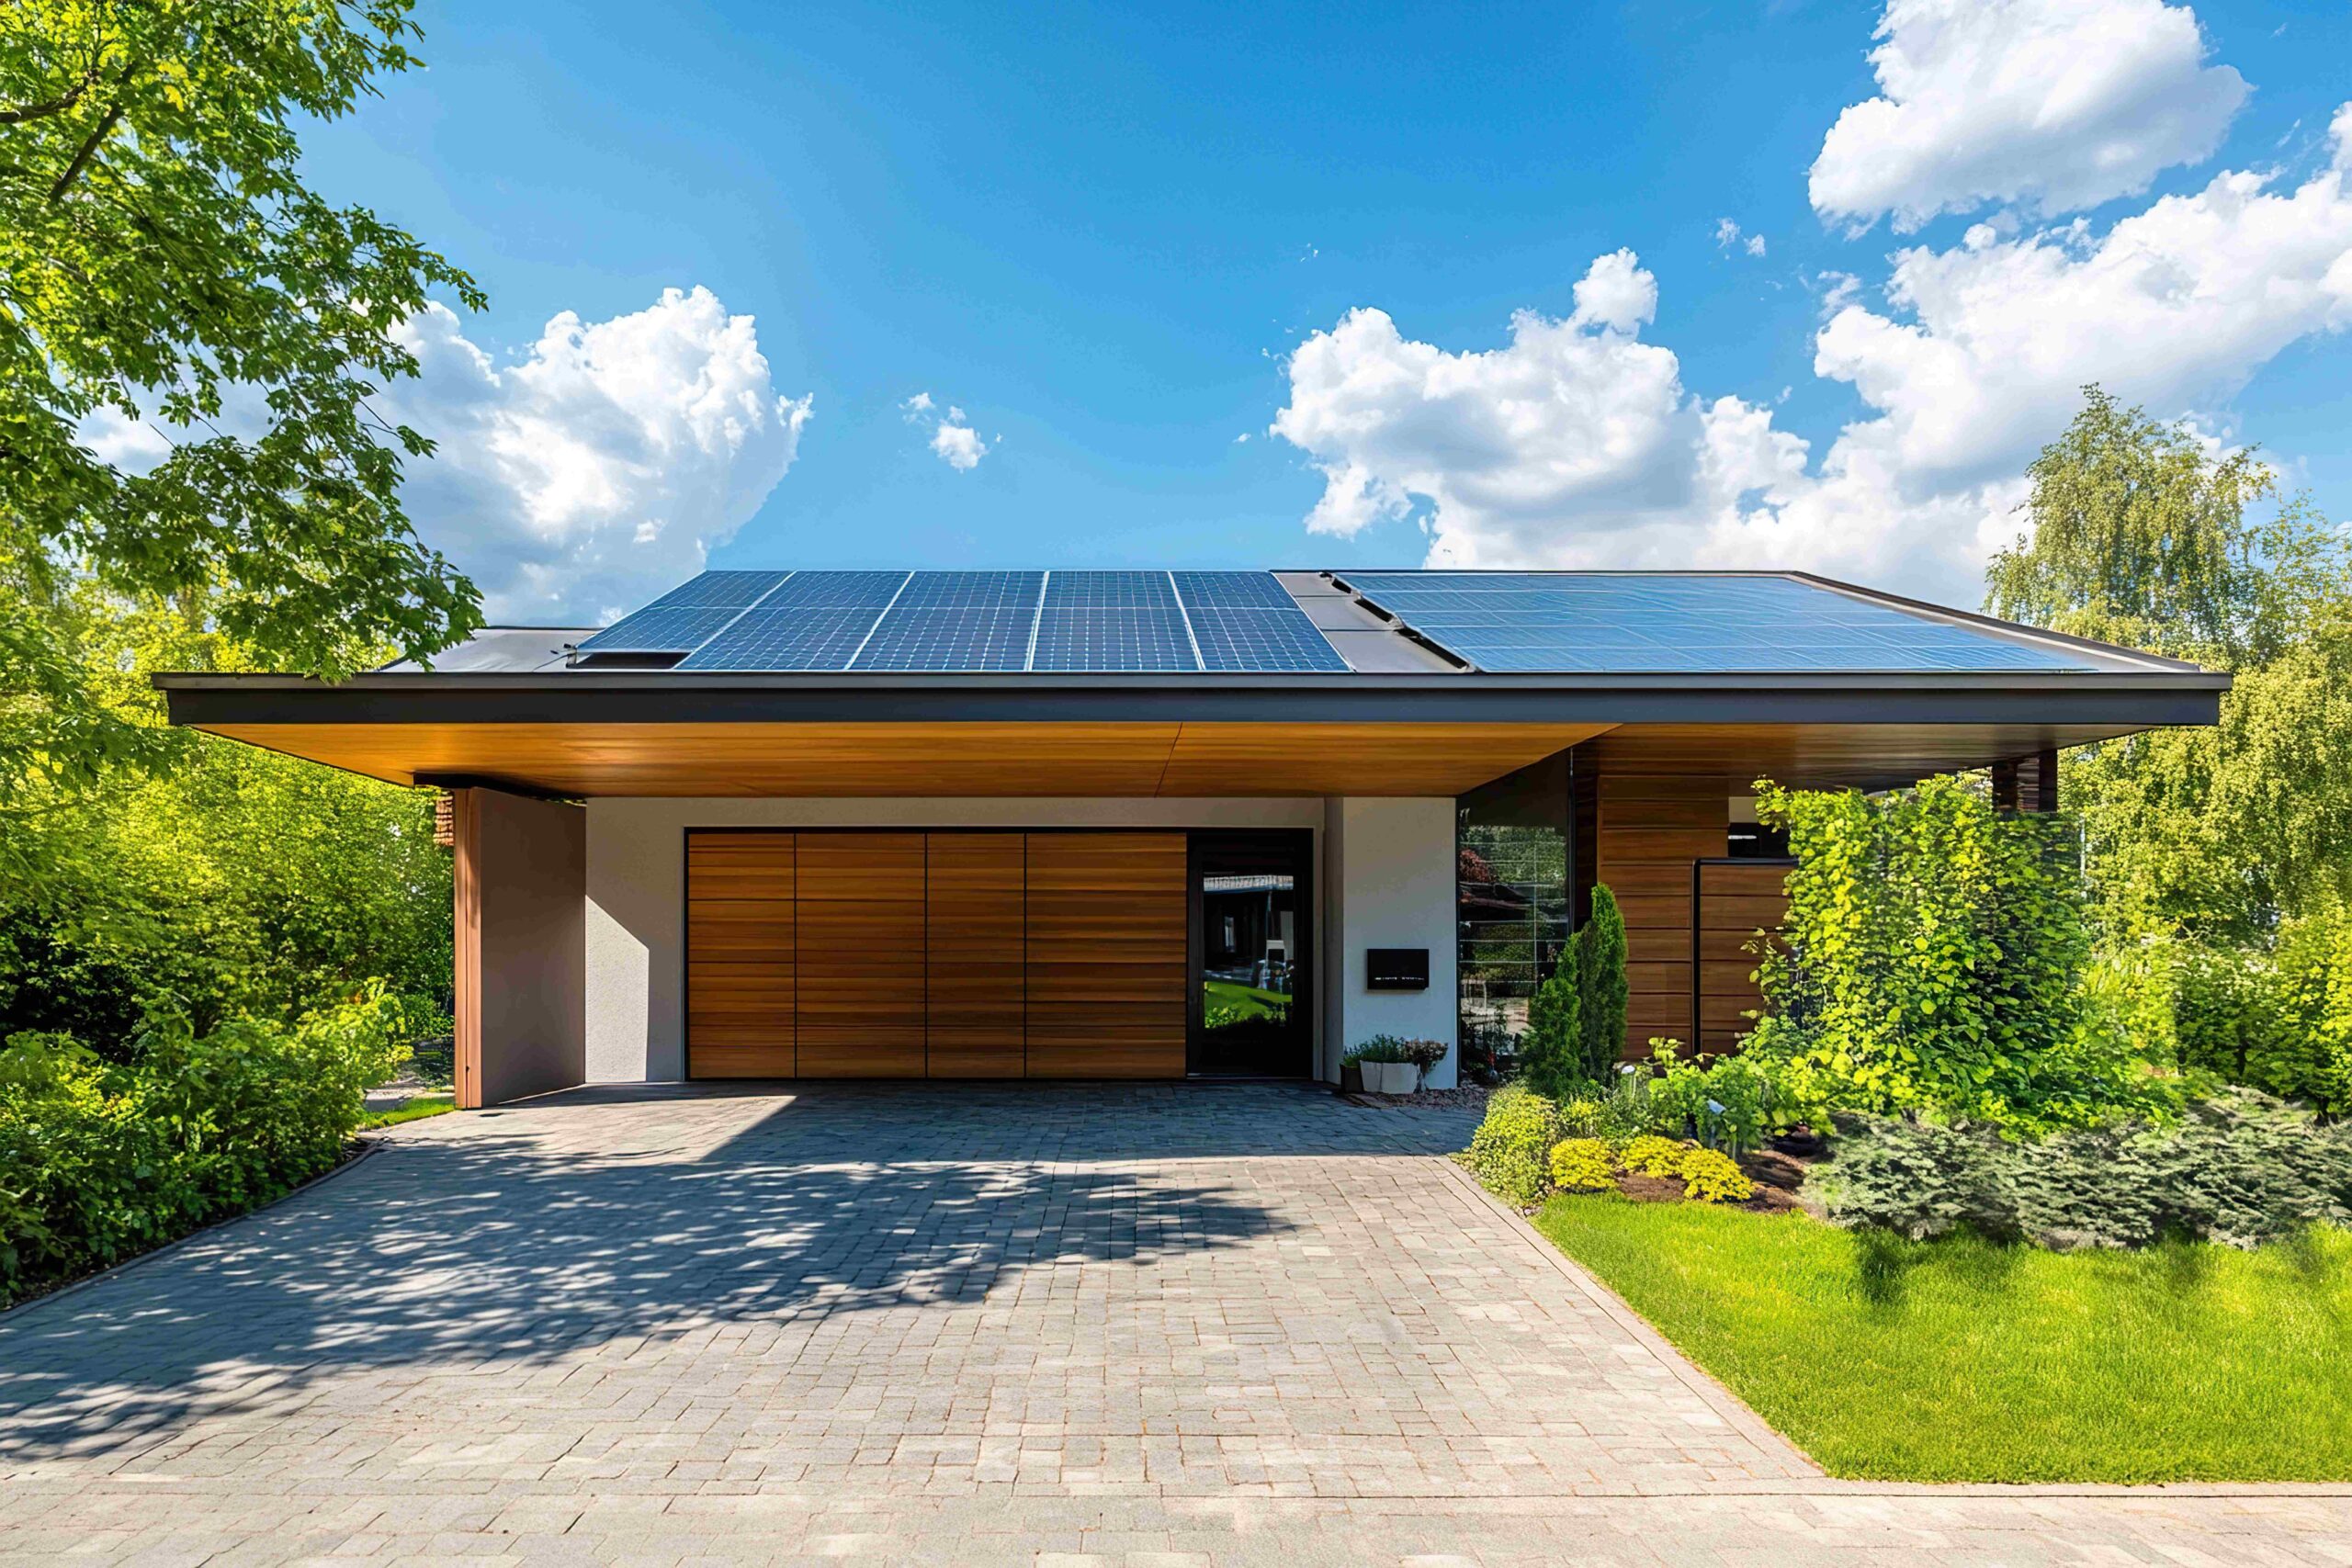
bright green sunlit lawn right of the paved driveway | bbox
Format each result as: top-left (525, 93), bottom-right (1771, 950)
top-left (1536, 1197), bottom-right (2352, 1481)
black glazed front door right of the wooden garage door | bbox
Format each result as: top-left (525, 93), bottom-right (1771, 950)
top-left (1188, 829), bottom-right (1315, 1079)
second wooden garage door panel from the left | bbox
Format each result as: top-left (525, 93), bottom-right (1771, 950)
top-left (795, 832), bottom-right (924, 1079)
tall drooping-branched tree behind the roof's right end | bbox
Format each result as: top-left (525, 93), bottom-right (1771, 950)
top-left (1987, 386), bottom-right (2352, 945)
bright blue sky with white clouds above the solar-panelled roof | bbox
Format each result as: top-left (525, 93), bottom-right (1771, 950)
top-left (306, 0), bottom-right (2352, 618)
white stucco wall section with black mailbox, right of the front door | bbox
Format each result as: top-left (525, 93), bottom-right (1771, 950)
top-left (1322, 797), bottom-right (1458, 1089)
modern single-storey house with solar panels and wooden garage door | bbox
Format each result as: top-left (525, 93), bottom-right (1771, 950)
top-left (158, 571), bottom-right (2227, 1105)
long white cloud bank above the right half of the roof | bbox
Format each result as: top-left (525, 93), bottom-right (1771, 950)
top-left (1272, 110), bottom-right (2352, 604)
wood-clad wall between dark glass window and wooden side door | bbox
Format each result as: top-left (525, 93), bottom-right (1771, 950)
top-left (1592, 773), bottom-right (1731, 1058)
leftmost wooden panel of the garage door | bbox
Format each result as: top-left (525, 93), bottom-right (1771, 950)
top-left (687, 832), bottom-right (797, 1079)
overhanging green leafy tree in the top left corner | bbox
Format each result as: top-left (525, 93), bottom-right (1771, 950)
top-left (0, 0), bottom-right (482, 804)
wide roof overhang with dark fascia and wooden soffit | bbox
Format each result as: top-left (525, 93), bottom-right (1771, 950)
top-left (155, 670), bottom-right (2230, 797)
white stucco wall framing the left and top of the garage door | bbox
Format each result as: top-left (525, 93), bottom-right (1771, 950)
top-left (588, 799), bottom-right (1326, 1084)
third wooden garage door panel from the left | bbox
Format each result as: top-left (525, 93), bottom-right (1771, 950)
top-left (924, 832), bottom-right (1028, 1079)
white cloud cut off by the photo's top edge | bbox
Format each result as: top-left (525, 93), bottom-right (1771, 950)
top-left (1811, 0), bottom-right (2246, 231)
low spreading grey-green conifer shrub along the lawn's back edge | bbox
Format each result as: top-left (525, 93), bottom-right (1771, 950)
top-left (1820, 1089), bottom-right (2352, 1248)
